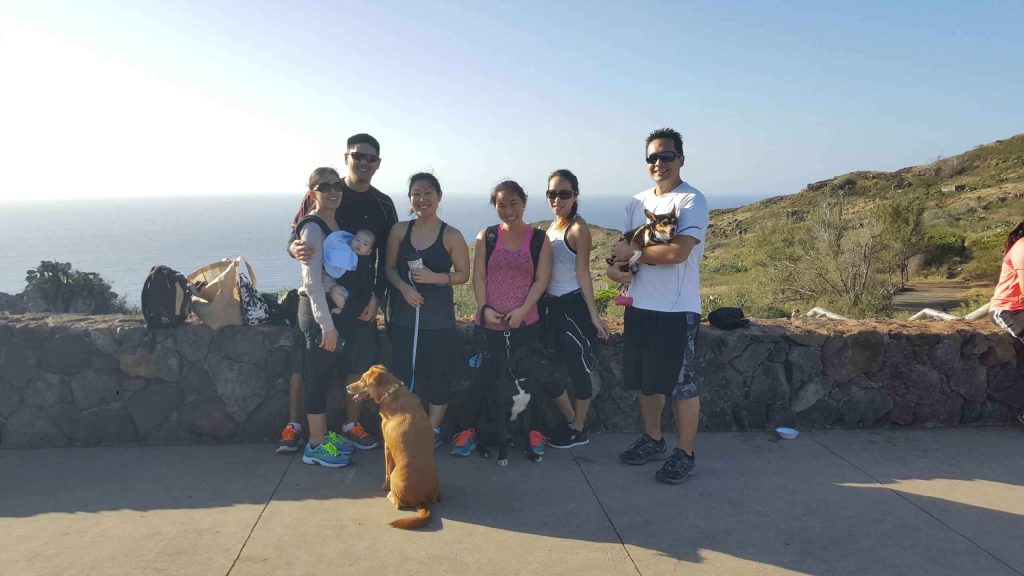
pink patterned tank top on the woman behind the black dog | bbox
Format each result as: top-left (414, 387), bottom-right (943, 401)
top-left (487, 225), bottom-right (540, 330)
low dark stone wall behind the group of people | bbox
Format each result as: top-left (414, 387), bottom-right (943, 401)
top-left (0, 314), bottom-right (1024, 448)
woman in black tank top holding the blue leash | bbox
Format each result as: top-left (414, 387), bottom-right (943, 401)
top-left (384, 172), bottom-right (469, 446)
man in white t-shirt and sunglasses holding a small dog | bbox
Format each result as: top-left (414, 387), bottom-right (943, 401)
top-left (607, 128), bottom-right (708, 484)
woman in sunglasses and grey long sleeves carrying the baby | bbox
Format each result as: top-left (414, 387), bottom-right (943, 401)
top-left (292, 168), bottom-right (352, 468)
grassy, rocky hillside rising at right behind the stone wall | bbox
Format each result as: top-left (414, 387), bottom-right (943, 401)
top-left (701, 134), bottom-right (1024, 314)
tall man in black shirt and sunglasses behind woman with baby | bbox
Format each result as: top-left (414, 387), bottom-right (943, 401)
top-left (288, 134), bottom-right (398, 450)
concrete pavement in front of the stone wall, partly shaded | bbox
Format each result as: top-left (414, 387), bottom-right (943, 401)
top-left (0, 427), bottom-right (1024, 576)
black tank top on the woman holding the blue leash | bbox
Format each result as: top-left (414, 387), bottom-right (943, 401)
top-left (391, 220), bottom-right (455, 330)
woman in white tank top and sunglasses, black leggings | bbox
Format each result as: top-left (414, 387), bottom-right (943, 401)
top-left (542, 170), bottom-right (608, 448)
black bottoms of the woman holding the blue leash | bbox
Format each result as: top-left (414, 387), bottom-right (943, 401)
top-left (390, 325), bottom-right (456, 406)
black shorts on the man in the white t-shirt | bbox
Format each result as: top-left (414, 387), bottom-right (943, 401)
top-left (623, 306), bottom-right (700, 400)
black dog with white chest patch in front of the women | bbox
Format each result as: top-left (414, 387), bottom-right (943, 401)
top-left (477, 343), bottom-right (561, 466)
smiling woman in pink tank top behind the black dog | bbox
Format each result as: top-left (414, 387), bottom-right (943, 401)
top-left (452, 180), bottom-right (564, 456)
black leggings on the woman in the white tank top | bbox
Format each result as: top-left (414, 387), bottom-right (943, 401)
top-left (541, 290), bottom-right (597, 400)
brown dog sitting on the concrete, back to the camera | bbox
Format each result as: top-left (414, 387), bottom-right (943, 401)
top-left (347, 364), bottom-right (441, 530)
